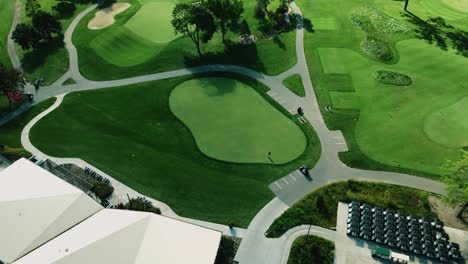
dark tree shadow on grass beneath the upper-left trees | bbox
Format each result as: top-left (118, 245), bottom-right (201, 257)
top-left (21, 35), bottom-right (64, 76)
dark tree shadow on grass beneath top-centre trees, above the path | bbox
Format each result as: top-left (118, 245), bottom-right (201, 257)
top-left (185, 41), bottom-right (265, 72)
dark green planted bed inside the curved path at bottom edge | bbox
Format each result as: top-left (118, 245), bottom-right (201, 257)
top-left (288, 236), bottom-right (335, 264)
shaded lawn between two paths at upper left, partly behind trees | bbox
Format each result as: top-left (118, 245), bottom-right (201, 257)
top-left (15, 0), bottom-right (87, 84)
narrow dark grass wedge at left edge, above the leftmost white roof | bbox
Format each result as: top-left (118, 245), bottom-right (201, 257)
top-left (0, 98), bottom-right (55, 148)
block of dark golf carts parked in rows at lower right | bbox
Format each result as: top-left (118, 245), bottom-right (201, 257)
top-left (347, 201), bottom-right (461, 262)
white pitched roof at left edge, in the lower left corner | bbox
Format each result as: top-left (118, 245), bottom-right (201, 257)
top-left (0, 159), bottom-right (102, 263)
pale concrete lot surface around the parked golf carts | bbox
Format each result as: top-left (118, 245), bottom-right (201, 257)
top-left (335, 203), bottom-right (468, 263)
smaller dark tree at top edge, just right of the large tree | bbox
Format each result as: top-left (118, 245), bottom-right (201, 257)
top-left (207, 0), bottom-right (244, 42)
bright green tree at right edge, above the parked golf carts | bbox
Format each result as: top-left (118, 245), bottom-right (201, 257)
top-left (441, 151), bottom-right (468, 217)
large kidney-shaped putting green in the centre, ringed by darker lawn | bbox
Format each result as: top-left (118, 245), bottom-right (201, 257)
top-left (169, 78), bottom-right (307, 164)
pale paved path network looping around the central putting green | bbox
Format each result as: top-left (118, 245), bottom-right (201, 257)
top-left (0, 2), bottom-right (445, 264)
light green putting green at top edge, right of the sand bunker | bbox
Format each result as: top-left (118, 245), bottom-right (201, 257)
top-left (125, 2), bottom-right (176, 43)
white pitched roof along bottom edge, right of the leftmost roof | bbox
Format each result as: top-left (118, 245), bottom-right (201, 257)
top-left (15, 209), bottom-right (221, 264)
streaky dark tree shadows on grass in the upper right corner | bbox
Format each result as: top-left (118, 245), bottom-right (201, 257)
top-left (402, 11), bottom-right (468, 57)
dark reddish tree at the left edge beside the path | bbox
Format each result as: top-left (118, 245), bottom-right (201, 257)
top-left (0, 64), bottom-right (26, 110)
